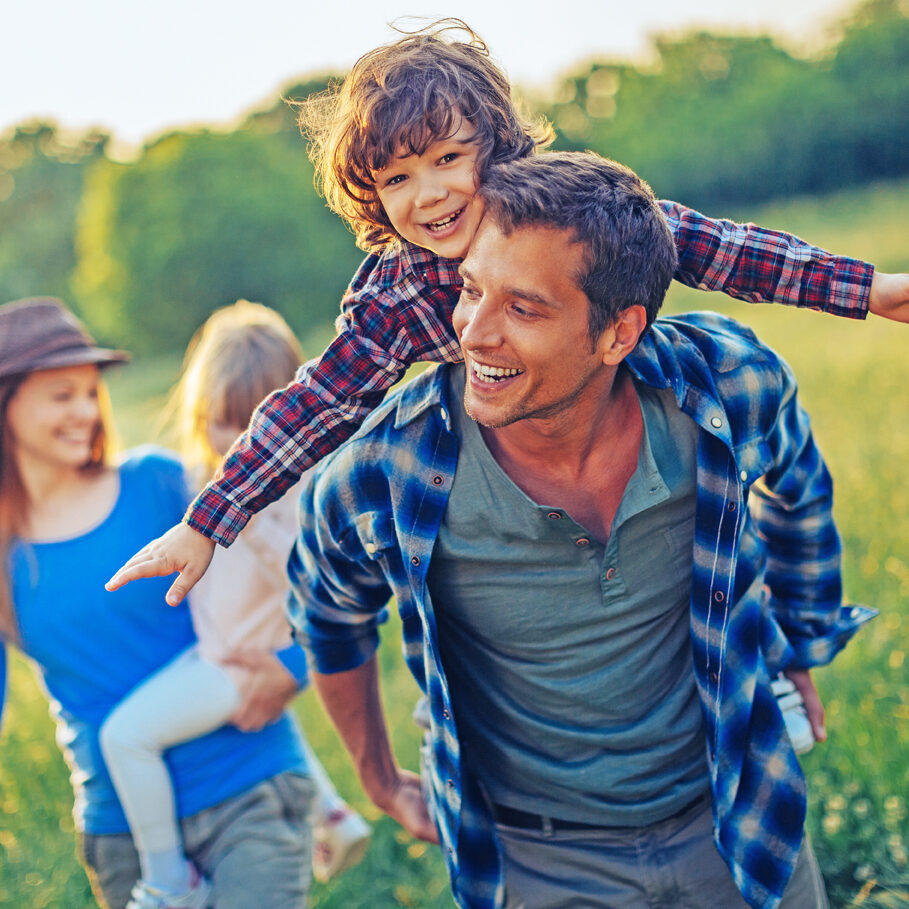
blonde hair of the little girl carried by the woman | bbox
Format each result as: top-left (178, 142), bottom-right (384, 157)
top-left (167, 300), bottom-right (303, 480)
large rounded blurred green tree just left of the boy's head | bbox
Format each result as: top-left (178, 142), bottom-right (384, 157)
top-left (74, 115), bottom-right (362, 351)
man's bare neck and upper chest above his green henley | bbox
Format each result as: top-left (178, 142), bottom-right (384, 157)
top-left (480, 369), bottom-right (643, 541)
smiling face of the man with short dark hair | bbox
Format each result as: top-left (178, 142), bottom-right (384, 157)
top-left (453, 218), bottom-right (604, 428)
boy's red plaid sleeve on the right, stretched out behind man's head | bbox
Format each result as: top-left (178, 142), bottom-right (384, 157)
top-left (660, 201), bottom-right (874, 319)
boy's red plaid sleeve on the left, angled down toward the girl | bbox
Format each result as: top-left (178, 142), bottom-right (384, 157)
top-left (184, 252), bottom-right (460, 546)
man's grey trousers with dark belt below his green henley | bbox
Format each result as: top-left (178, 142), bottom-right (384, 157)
top-left (496, 800), bottom-right (828, 909)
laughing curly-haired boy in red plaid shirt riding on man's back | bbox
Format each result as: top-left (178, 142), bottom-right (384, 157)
top-left (107, 20), bottom-right (909, 605)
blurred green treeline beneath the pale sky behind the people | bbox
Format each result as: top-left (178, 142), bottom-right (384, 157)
top-left (0, 0), bottom-right (909, 354)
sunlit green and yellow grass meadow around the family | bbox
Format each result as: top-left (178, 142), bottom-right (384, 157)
top-left (0, 181), bottom-right (909, 909)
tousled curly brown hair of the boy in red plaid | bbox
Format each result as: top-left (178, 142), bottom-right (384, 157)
top-left (298, 19), bottom-right (554, 252)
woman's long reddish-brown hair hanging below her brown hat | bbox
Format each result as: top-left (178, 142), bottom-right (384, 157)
top-left (0, 374), bottom-right (115, 642)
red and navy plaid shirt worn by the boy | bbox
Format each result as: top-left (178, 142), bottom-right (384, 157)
top-left (184, 202), bottom-right (873, 546)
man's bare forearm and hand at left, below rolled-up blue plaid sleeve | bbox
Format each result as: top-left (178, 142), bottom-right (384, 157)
top-left (312, 656), bottom-right (439, 843)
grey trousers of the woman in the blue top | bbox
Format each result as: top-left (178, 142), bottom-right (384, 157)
top-left (80, 771), bottom-right (315, 909)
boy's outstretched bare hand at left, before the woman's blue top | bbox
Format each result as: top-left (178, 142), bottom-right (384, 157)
top-left (104, 524), bottom-right (215, 606)
